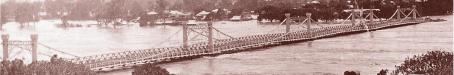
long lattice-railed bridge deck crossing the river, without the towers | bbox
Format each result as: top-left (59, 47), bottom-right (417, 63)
top-left (69, 18), bottom-right (426, 72)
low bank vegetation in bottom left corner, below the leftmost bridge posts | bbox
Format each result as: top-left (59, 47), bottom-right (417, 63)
top-left (0, 55), bottom-right (96, 75)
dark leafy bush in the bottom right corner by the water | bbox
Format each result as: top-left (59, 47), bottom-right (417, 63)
top-left (395, 51), bottom-right (453, 75)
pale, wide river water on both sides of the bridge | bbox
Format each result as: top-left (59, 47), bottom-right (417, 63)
top-left (2, 15), bottom-right (453, 75)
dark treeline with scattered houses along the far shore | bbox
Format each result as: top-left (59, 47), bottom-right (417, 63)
top-left (0, 0), bottom-right (453, 24)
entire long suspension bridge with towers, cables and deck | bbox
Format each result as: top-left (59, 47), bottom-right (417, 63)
top-left (2, 6), bottom-right (428, 72)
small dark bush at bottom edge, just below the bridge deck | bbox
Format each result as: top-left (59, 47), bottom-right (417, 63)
top-left (132, 64), bottom-right (170, 75)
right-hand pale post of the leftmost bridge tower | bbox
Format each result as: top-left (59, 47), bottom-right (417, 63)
top-left (30, 34), bottom-right (38, 63)
